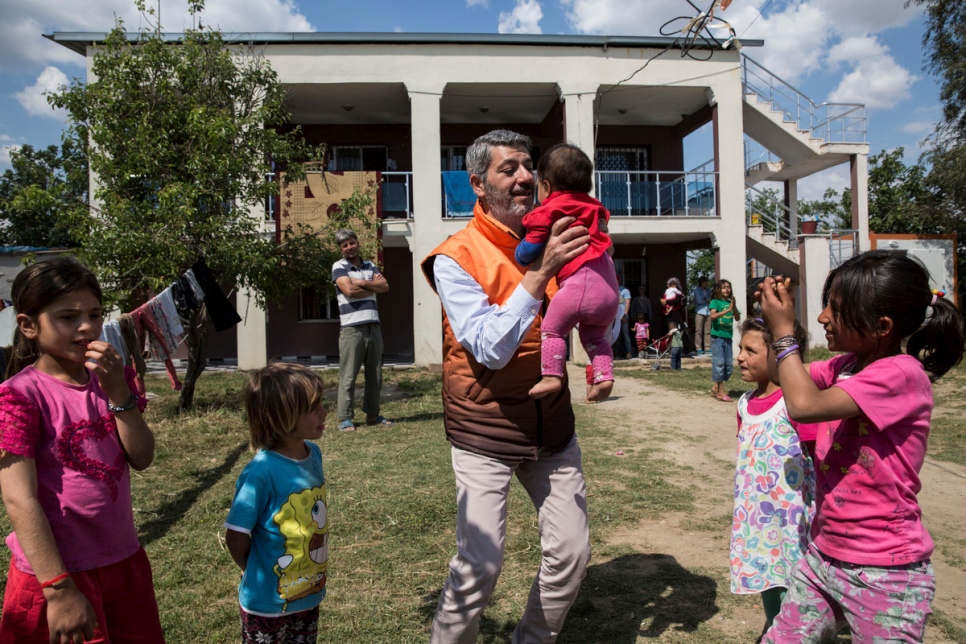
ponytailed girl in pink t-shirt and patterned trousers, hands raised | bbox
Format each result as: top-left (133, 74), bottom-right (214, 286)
top-left (759, 251), bottom-right (964, 642)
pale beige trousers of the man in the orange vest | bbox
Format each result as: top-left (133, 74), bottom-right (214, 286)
top-left (430, 437), bottom-right (590, 644)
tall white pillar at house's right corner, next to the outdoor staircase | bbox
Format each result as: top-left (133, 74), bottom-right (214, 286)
top-left (708, 86), bottom-right (749, 348)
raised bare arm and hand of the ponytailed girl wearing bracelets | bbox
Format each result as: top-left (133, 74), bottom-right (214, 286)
top-left (758, 277), bottom-right (862, 423)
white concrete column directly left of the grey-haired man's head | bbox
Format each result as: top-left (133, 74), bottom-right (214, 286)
top-left (406, 82), bottom-right (452, 366)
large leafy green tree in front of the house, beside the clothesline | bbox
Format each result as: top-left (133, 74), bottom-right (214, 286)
top-left (49, 0), bottom-right (356, 409)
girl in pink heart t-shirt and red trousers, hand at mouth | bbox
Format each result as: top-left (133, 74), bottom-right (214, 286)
top-left (0, 257), bottom-right (164, 642)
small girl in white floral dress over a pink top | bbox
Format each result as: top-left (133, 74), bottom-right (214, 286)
top-left (731, 318), bottom-right (815, 633)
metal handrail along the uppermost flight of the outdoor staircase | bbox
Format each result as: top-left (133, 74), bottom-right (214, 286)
top-left (741, 55), bottom-right (866, 143)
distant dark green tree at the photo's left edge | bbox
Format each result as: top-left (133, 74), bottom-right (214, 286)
top-left (0, 140), bottom-right (88, 248)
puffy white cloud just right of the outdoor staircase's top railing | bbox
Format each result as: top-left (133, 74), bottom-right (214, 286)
top-left (828, 36), bottom-right (917, 109)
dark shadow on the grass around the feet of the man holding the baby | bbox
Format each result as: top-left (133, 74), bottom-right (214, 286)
top-left (420, 554), bottom-right (718, 644)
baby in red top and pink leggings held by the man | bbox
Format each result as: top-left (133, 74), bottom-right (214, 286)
top-left (516, 143), bottom-right (616, 402)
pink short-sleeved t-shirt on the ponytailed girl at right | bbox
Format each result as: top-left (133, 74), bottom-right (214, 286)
top-left (810, 354), bottom-right (933, 566)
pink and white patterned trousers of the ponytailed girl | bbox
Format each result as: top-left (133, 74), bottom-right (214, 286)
top-left (761, 544), bottom-right (936, 644)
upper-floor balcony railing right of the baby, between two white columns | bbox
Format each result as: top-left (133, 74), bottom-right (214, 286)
top-left (596, 170), bottom-right (718, 217)
